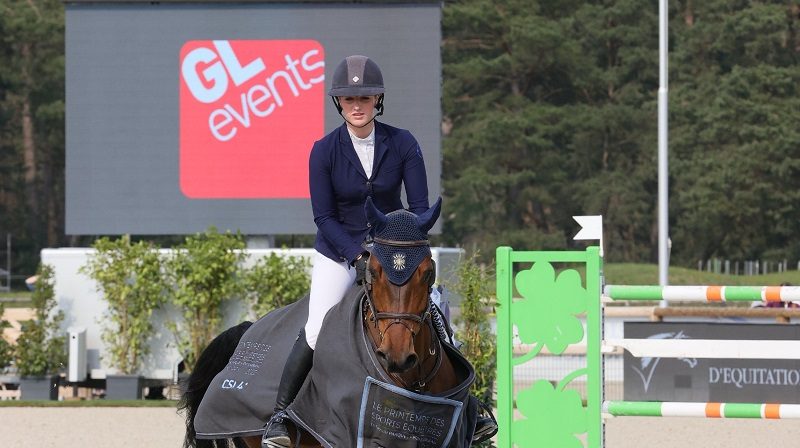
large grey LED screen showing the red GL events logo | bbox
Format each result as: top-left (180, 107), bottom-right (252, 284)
top-left (66, 2), bottom-right (441, 235)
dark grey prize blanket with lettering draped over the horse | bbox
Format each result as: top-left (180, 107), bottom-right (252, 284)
top-left (195, 288), bottom-right (478, 448)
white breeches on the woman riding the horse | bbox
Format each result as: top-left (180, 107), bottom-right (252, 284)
top-left (305, 252), bottom-right (356, 349)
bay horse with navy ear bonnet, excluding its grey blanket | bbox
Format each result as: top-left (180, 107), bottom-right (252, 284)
top-left (180, 199), bottom-right (474, 448)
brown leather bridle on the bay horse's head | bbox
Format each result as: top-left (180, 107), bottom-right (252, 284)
top-left (363, 238), bottom-right (442, 390)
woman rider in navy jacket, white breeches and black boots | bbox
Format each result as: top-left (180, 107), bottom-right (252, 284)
top-left (263, 55), bottom-right (428, 447)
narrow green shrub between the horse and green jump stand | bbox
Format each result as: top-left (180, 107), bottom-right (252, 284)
top-left (450, 252), bottom-right (497, 403)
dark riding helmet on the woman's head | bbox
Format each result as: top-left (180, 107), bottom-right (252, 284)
top-left (328, 55), bottom-right (385, 117)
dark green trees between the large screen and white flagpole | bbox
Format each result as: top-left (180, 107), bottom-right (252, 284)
top-left (443, 0), bottom-right (658, 259)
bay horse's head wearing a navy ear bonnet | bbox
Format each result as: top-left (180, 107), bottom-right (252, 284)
top-left (366, 199), bottom-right (442, 373)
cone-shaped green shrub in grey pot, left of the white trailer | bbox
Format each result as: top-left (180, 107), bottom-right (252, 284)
top-left (15, 264), bottom-right (67, 376)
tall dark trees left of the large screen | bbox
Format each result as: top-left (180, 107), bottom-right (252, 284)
top-left (0, 0), bottom-right (69, 273)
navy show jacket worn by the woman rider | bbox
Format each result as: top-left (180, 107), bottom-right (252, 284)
top-left (308, 121), bottom-right (428, 263)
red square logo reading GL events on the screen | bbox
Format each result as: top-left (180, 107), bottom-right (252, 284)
top-left (180, 40), bottom-right (325, 199)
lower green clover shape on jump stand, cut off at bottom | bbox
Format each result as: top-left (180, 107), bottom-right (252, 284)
top-left (511, 380), bottom-right (588, 448)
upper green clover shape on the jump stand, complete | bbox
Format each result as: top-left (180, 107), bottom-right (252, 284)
top-left (511, 262), bottom-right (588, 355)
